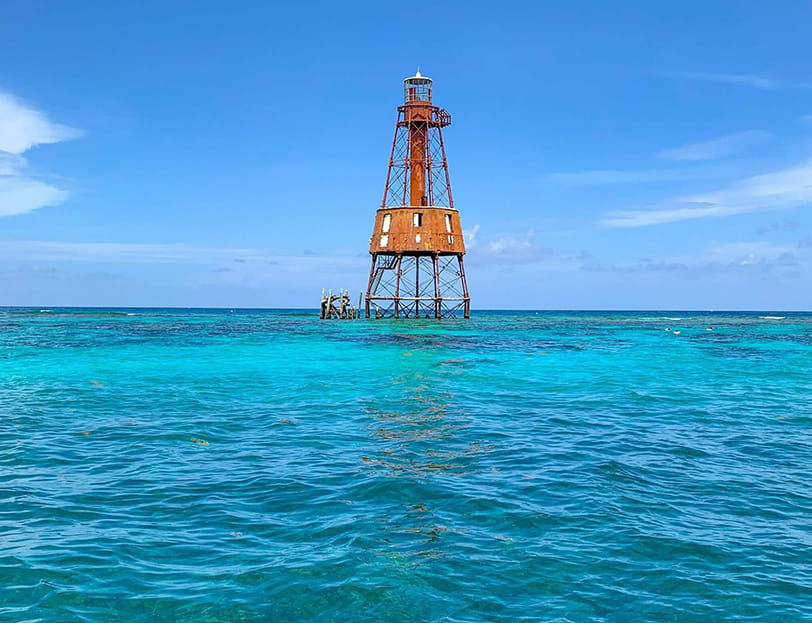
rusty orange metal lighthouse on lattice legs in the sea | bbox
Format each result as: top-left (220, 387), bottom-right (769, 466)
top-left (364, 71), bottom-right (471, 318)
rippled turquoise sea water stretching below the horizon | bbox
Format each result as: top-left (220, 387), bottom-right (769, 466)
top-left (0, 309), bottom-right (812, 623)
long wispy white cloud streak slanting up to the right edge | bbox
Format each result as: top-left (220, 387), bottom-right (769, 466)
top-left (601, 160), bottom-right (812, 227)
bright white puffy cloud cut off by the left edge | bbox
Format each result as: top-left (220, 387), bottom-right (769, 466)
top-left (0, 93), bottom-right (81, 217)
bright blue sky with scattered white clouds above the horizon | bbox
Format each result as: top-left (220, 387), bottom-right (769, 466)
top-left (0, 0), bottom-right (812, 310)
